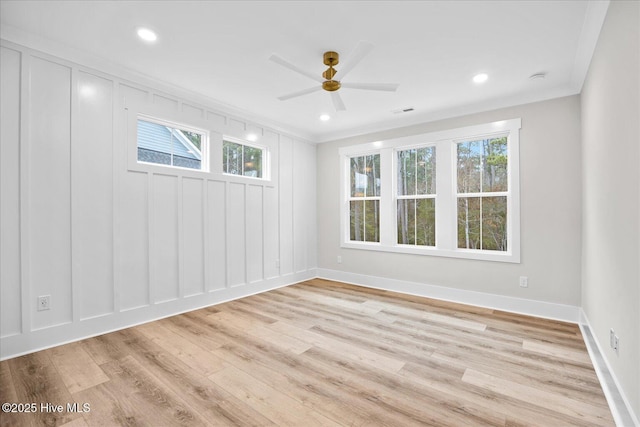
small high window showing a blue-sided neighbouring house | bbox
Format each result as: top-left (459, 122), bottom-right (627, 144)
top-left (137, 118), bottom-right (208, 170)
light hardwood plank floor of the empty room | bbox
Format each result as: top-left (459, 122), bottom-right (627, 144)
top-left (0, 279), bottom-right (614, 427)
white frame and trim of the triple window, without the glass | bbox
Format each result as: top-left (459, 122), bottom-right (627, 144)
top-left (339, 118), bottom-right (521, 263)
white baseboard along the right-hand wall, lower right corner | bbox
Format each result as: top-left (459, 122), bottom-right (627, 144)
top-left (579, 309), bottom-right (640, 427)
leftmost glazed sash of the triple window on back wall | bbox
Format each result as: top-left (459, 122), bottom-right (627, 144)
top-left (349, 154), bottom-right (380, 242)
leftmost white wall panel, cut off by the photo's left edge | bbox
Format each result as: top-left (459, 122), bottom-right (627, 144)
top-left (0, 47), bottom-right (22, 337)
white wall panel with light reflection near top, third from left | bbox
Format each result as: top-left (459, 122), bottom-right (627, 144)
top-left (71, 72), bottom-right (115, 319)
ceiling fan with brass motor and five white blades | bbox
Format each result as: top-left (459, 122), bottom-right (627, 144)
top-left (269, 41), bottom-right (398, 111)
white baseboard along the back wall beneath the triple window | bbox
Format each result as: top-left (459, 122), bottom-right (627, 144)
top-left (318, 268), bottom-right (580, 323)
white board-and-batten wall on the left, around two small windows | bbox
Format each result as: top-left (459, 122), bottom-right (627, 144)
top-left (0, 42), bottom-right (316, 358)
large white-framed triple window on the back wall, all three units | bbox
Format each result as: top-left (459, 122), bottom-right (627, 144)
top-left (339, 119), bottom-right (520, 262)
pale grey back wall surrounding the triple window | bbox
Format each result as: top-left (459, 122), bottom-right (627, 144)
top-left (318, 96), bottom-right (581, 321)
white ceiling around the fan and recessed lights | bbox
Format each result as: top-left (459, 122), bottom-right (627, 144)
top-left (0, 0), bottom-right (608, 142)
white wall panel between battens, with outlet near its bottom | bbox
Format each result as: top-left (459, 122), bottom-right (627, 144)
top-left (29, 56), bottom-right (73, 329)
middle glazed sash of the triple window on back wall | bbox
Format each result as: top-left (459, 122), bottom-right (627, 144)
top-left (396, 147), bottom-right (436, 246)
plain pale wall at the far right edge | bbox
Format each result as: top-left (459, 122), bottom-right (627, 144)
top-left (581, 1), bottom-right (640, 417)
